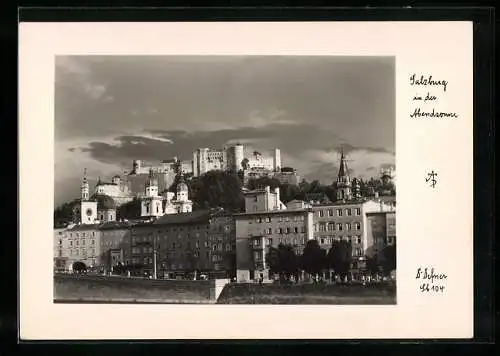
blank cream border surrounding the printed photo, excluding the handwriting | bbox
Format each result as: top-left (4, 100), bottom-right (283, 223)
top-left (19, 22), bottom-right (473, 339)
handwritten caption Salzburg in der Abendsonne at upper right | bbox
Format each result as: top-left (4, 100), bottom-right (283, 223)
top-left (410, 74), bottom-right (458, 119)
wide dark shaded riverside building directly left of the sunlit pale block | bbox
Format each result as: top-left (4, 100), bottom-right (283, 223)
top-left (130, 210), bottom-right (235, 278)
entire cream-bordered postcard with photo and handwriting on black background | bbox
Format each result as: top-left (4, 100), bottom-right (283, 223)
top-left (19, 22), bottom-right (473, 340)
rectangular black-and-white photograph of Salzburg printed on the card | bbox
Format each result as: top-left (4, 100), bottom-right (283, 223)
top-left (53, 55), bottom-right (397, 305)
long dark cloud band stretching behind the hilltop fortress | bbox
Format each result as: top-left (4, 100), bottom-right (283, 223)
top-left (70, 125), bottom-right (387, 169)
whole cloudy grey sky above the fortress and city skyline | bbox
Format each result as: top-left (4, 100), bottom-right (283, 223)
top-left (54, 56), bottom-right (395, 206)
